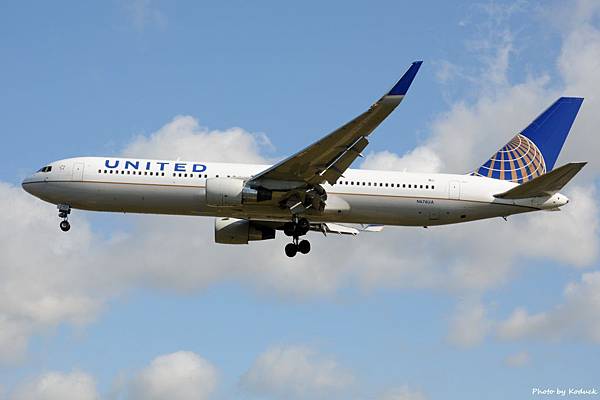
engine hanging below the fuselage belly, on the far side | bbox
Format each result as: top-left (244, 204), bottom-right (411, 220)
top-left (215, 218), bottom-right (275, 244)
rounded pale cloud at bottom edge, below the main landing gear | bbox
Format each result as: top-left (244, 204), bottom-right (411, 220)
top-left (240, 346), bottom-right (354, 399)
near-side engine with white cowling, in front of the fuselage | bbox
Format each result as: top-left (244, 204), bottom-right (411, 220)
top-left (206, 178), bottom-right (272, 207)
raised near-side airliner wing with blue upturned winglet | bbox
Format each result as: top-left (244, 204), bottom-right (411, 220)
top-left (251, 61), bottom-right (422, 185)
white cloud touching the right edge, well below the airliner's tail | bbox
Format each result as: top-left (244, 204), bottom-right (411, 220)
top-left (497, 271), bottom-right (600, 343)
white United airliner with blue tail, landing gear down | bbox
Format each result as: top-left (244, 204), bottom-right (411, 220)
top-left (22, 61), bottom-right (586, 257)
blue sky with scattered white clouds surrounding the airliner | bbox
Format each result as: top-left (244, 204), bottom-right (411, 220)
top-left (0, 0), bottom-right (600, 400)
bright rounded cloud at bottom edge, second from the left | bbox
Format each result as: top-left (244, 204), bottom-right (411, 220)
top-left (128, 351), bottom-right (218, 400)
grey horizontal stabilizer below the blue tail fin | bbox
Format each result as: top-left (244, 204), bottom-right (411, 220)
top-left (494, 162), bottom-right (587, 199)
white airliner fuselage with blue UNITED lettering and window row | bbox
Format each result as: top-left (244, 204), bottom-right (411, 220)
top-left (23, 157), bottom-right (568, 226)
